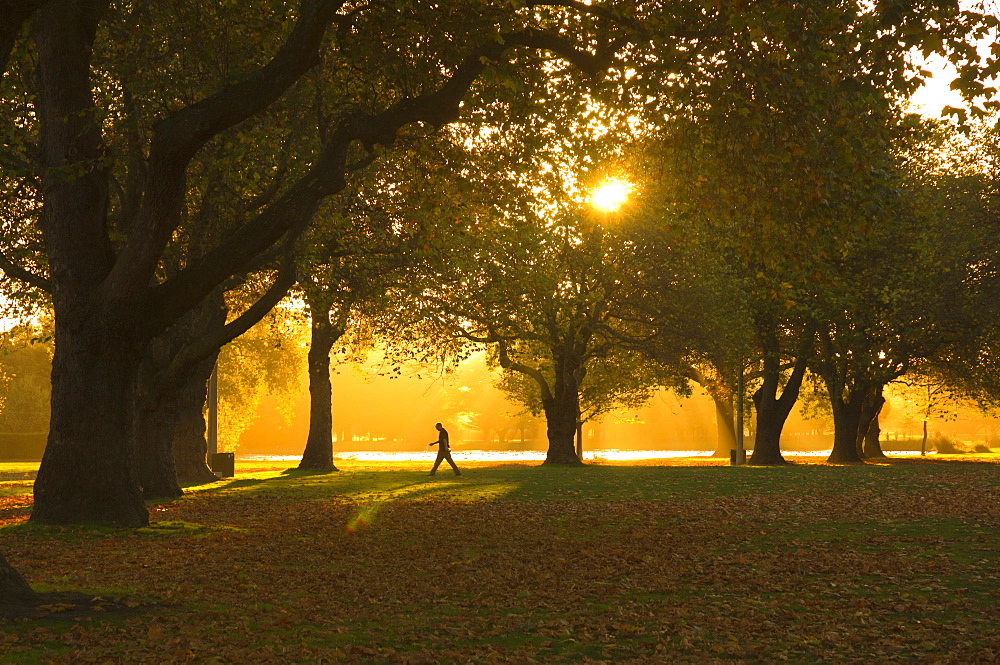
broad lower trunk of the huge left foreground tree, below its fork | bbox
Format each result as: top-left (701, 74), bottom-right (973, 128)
top-left (31, 320), bottom-right (149, 527)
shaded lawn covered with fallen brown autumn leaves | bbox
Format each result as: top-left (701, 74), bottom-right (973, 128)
top-left (0, 454), bottom-right (1000, 664)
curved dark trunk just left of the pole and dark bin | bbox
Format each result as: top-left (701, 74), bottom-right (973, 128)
top-left (174, 353), bottom-right (219, 485)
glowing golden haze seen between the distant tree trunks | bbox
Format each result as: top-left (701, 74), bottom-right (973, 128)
top-left (232, 348), bottom-right (1000, 455)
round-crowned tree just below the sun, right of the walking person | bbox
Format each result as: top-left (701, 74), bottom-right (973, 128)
top-left (417, 205), bottom-right (676, 464)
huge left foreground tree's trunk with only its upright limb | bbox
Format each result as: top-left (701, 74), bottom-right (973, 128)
top-left (31, 2), bottom-right (147, 526)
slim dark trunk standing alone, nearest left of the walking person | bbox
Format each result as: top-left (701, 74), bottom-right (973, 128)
top-left (299, 309), bottom-right (342, 471)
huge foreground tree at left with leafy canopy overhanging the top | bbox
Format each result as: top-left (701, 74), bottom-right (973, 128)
top-left (0, 0), bottom-right (996, 525)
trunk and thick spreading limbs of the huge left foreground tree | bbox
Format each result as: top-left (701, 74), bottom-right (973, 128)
top-left (7, 0), bottom-right (628, 526)
